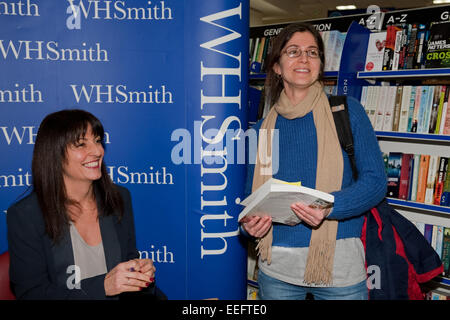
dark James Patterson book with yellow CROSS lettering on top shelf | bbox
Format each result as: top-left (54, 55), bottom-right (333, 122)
top-left (424, 21), bottom-right (450, 68)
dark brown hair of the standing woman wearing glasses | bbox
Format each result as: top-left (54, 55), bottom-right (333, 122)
top-left (265, 23), bottom-right (325, 106)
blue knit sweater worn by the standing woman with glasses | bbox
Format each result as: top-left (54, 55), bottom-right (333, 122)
top-left (245, 97), bottom-right (387, 247)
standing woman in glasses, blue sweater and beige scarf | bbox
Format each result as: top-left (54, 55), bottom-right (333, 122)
top-left (242, 24), bottom-right (386, 300)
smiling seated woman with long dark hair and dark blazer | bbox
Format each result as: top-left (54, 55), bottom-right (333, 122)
top-left (7, 110), bottom-right (162, 299)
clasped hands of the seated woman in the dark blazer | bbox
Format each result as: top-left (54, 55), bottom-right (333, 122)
top-left (104, 259), bottom-right (155, 296)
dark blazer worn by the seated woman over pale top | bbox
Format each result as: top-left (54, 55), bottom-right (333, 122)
top-left (7, 186), bottom-right (154, 299)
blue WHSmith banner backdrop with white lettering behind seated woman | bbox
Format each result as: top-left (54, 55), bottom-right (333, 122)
top-left (0, 0), bottom-right (249, 299)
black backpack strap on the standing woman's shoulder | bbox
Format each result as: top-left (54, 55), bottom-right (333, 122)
top-left (328, 96), bottom-right (358, 180)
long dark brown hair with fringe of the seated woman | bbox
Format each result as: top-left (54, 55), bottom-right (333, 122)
top-left (32, 109), bottom-right (123, 243)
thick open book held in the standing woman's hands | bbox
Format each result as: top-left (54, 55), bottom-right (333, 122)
top-left (238, 178), bottom-right (334, 225)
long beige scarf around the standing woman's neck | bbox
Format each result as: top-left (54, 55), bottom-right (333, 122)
top-left (252, 81), bottom-right (344, 285)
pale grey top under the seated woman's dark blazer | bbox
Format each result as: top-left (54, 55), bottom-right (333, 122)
top-left (70, 223), bottom-right (107, 280)
